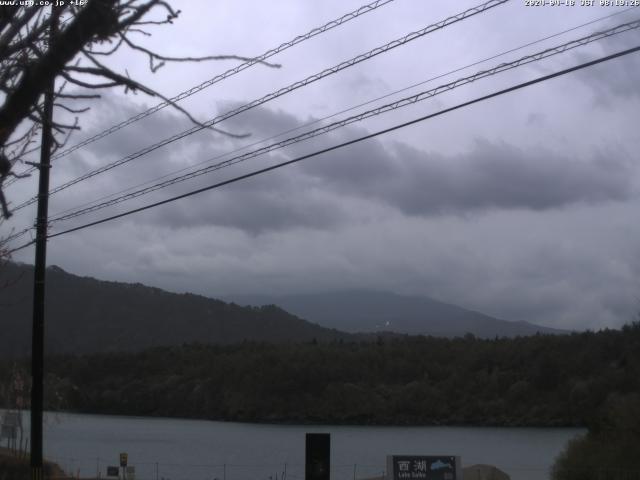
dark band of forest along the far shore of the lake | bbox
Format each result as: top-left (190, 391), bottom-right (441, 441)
top-left (0, 323), bottom-right (640, 426)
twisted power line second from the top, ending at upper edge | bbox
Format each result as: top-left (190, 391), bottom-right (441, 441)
top-left (8, 0), bottom-right (509, 212)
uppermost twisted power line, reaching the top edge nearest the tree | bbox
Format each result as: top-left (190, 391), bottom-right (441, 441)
top-left (7, 0), bottom-right (394, 185)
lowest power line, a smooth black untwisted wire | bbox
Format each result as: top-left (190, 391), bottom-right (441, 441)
top-left (9, 45), bottom-right (640, 253)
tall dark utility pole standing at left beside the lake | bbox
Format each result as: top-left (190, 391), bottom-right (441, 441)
top-left (31, 6), bottom-right (58, 480)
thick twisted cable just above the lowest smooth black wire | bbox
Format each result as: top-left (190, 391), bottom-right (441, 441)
top-left (51, 20), bottom-right (640, 222)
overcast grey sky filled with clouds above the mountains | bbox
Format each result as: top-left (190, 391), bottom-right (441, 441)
top-left (0, 0), bottom-right (640, 329)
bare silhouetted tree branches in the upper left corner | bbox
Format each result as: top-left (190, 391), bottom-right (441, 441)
top-left (0, 0), bottom-right (274, 219)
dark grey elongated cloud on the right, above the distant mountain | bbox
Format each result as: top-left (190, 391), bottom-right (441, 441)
top-left (296, 129), bottom-right (633, 215)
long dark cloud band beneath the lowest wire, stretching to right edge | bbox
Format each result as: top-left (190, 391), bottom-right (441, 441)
top-left (134, 131), bottom-right (634, 233)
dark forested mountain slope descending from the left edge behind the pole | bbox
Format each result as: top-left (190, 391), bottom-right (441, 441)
top-left (0, 263), bottom-right (350, 356)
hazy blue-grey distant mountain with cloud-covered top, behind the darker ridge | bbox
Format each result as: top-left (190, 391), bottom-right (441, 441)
top-left (229, 290), bottom-right (567, 338)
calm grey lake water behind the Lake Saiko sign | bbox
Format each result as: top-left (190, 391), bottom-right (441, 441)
top-left (17, 414), bottom-right (582, 480)
